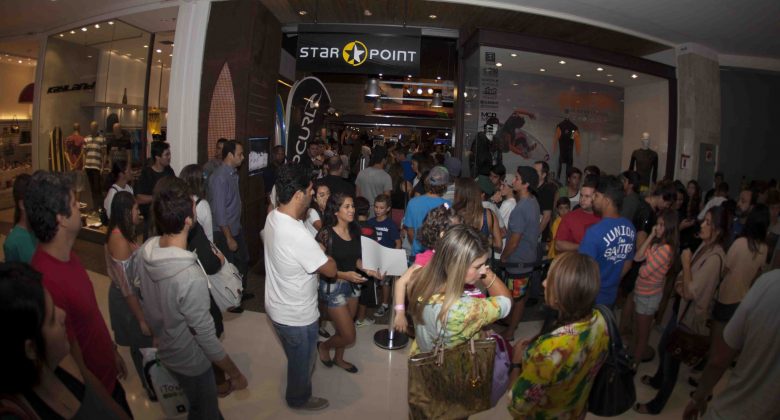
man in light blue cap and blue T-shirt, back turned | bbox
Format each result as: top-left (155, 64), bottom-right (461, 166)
top-left (403, 166), bottom-right (452, 256)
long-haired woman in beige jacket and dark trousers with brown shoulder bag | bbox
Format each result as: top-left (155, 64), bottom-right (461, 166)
top-left (634, 206), bottom-right (729, 414)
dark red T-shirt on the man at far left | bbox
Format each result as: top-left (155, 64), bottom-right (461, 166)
top-left (30, 247), bottom-right (118, 394)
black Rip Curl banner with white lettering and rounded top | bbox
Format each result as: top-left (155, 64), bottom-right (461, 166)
top-left (285, 77), bottom-right (330, 163)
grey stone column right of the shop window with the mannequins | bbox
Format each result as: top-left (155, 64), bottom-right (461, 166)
top-left (674, 44), bottom-right (721, 185)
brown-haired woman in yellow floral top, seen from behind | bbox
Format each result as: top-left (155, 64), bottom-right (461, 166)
top-left (509, 252), bottom-right (609, 419)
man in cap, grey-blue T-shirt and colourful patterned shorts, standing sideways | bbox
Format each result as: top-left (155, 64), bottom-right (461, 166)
top-left (501, 166), bottom-right (540, 341)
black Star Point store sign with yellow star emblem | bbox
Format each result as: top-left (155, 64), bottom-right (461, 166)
top-left (295, 24), bottom-right (422, 76)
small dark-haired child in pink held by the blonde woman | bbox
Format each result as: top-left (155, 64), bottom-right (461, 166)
top-left (393, 203), bottom-right (463, 334)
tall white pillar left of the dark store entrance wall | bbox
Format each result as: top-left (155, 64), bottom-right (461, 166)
top-left (168, 0), bottom-right (211, 174)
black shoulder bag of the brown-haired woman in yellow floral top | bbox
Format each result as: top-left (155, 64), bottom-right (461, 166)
top-left (588, 305), bottom-right (636, 417)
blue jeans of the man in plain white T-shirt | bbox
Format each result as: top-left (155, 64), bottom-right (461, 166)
top-left (271, 321), bottom-right (319, 407)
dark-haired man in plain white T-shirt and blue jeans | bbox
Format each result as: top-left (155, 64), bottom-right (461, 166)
top-left (262, 165), bottom-right (336, 410)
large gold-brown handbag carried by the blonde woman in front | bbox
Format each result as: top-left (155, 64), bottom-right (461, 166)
top-left (408, 321), bottom-right (496, 419)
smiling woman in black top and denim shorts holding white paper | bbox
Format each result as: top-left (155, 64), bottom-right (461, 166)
top-left (316, 193), bottom-right (382, 373)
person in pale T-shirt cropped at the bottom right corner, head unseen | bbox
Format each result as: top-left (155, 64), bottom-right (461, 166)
top-left (683, 270), bottom-right (780, 419)
